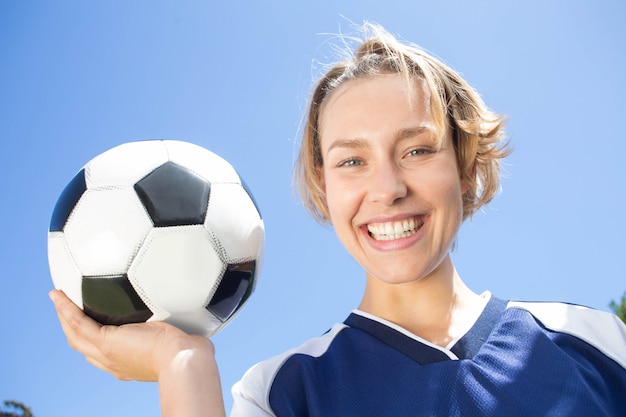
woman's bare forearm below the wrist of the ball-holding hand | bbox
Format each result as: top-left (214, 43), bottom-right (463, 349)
top-left (158, 342), bottom-right (226, 417)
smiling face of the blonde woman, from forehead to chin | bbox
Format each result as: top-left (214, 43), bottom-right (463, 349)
top-left (319, 75), bottom-right (466, 283)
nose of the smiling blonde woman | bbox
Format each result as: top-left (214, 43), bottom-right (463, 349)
top-left (369, 162), bottom-right (408, 206)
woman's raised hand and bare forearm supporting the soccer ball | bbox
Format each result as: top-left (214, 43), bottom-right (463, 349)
top-left (50, 290), bottom-right (226, 417)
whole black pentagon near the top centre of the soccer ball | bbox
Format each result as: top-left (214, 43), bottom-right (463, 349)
top-left (135, 162), bottom-right (211, 227)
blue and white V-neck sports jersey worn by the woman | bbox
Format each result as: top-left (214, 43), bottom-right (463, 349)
top-left (231, 297), bottom-right (626, 417)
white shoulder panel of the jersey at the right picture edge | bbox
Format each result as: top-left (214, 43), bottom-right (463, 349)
top-left (507, 301), bottom-right (626, 368)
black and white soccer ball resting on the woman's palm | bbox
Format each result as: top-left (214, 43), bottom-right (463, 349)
top-left (48, 140), bottom-right (264, 337)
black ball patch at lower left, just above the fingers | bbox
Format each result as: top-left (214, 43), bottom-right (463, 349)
top-left (82, 275), bottom-right (152, 325)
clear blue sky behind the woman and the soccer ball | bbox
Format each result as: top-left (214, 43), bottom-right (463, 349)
top-left (0, 0), bottom-right (626, 417)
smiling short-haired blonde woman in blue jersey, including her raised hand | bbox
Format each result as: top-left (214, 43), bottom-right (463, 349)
top-left (51, 25), bottom-right (626, 416)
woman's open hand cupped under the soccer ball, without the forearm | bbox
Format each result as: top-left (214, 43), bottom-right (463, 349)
top-left (50, 290), bottom-right (215, 381)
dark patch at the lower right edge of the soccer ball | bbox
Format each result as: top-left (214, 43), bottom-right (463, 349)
top-left (207, 261), bottom-right (256, 322)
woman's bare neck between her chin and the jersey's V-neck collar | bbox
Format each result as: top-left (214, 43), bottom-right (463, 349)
top-left (359, 256), bottom-right (487, 347)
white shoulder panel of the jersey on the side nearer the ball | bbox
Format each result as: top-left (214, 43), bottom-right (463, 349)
top-left (231, 323), bottom-right (348, 416)
